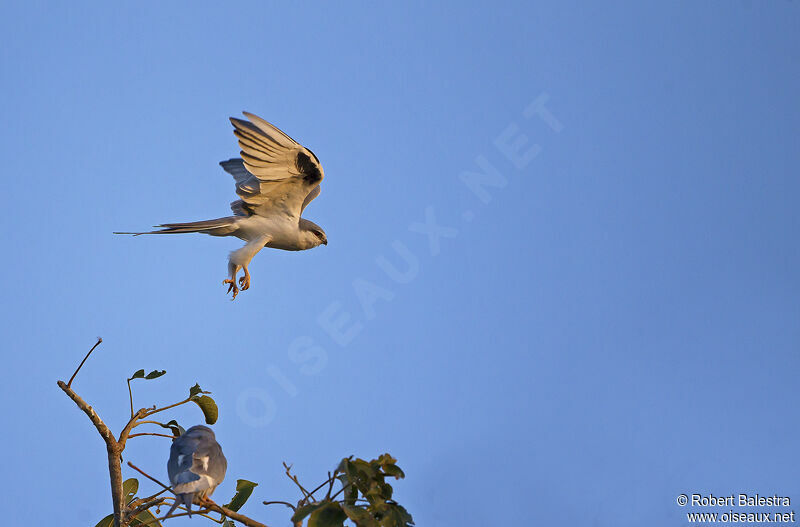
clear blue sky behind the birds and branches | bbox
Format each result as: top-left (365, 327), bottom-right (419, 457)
top-left (0, 1), bottom-right (800, 526)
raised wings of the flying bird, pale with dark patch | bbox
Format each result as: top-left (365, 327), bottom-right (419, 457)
top-left (220, 112), bottom-right (324, 219)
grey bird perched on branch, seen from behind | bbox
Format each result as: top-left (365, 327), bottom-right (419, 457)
top-left (167, 425), bottom-right (228, 516)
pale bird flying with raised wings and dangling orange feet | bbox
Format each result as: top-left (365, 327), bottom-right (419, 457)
top-left (115, 112), bottom-right (328, 300)
